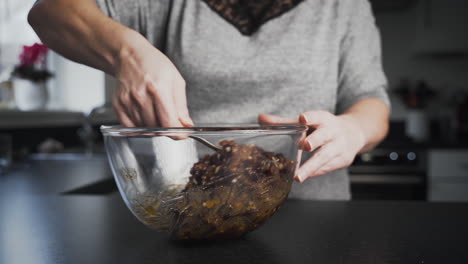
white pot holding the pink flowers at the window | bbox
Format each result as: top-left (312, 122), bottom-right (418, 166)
top-left (13, 78), bottom-right (48, 111)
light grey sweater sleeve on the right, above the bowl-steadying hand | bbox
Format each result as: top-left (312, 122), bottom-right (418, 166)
top-left (336, 0), bottom-right (390, 114)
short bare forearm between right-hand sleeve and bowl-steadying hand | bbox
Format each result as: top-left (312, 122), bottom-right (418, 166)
top-left (340, 98), bottom-right (390, 152)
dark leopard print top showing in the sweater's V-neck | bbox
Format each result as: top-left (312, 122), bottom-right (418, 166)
top-left (203, 0), bottom-right (304, 35)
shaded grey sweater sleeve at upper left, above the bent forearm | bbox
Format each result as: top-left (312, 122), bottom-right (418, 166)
top-left (95, 0), bottom-right (172, 50)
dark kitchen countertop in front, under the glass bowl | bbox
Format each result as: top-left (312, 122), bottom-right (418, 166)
top-left (0, 156), bottom-right (468, 264)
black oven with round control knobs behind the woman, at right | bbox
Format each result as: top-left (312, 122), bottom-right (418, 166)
top-left (349, 147), bottom-right (427, 200)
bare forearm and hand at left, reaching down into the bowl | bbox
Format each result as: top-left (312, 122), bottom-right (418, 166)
top-left (28, 0), bottom-right (192, 127)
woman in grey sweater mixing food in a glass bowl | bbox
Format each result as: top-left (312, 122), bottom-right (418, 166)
top-left (28, 0), bottom-right (389, 199)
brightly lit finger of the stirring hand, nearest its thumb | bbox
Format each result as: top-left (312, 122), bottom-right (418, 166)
top-left (148, 79), bottom-right (182, 127)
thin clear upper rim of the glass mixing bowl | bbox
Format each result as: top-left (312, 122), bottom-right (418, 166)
top-left (100, 124), bottom-right (307, 137)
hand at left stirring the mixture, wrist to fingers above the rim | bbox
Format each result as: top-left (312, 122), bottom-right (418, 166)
top-left (113, 32), bottom-right (193, 127)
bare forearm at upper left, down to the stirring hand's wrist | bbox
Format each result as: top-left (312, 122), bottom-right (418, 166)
top-left (28, 0), bottom-right (142, 75)
